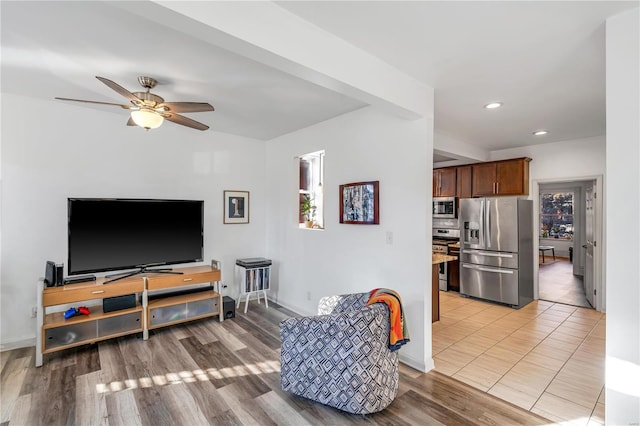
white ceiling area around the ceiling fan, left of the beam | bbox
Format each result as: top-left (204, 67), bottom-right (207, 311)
top-left (1, 1), bottom-right (364, 140)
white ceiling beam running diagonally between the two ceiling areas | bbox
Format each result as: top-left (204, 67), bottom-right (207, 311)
top-left (116, 1), bottom-right (433, 119)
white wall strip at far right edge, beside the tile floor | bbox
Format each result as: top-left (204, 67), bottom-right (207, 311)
top-left (605, 8), bottom-right (640, 425)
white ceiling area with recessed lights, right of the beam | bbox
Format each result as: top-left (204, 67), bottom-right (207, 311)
top-left (279, 1), bottom-right (639, 150)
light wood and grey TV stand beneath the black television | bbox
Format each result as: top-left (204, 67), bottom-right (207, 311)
top-left (35, 262), bottom-right (224, 367)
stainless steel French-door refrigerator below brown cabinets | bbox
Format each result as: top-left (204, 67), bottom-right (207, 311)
top-left (459, 197), bottom-right (534, 308)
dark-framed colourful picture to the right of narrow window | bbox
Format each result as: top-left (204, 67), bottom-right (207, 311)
top-left (340, 180), bottom-right (380, 225)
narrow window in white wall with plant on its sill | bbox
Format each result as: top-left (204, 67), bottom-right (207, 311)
top-left (298, 151), bottom-right (324, 229)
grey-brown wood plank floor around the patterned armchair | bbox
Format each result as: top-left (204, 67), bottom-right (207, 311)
top-left (0, 302), bottom-right (549, 426)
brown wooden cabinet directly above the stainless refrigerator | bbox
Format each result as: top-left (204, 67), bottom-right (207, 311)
top-left (471, 158), bottom-right (531, 197)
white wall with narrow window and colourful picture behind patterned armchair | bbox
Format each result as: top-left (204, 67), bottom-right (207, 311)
top-left (267, 107), bottom-right (433, 370)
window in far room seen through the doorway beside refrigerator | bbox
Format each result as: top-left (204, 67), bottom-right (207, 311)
top-left (540, 192), bottom-right (574, 240)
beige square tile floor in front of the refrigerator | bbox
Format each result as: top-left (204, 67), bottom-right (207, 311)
top-left (433, 292), bottom-right (606, 425)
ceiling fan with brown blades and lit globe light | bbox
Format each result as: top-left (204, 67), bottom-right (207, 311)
top-left (55, 76), bottom-right (213, 130)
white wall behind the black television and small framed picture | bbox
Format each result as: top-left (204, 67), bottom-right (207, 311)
top-left (0, 95), bottom-right (266, 348)
